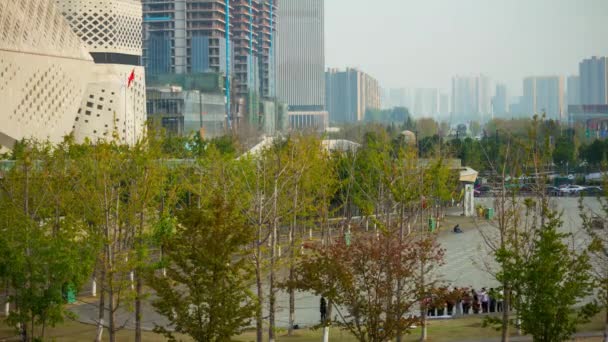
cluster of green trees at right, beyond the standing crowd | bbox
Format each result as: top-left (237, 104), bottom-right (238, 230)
top-left (480, 117), bottom-right (608, 341)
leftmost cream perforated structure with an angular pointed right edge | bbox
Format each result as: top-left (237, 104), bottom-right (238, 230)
top-left (0, 0), bottom-right (93, 146)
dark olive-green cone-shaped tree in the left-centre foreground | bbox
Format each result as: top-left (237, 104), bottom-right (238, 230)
top-left (148, 154), bottom-right (256, 341)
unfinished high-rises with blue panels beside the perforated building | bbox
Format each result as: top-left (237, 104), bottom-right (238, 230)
top-left (142, 0), bottom-right (277, 97)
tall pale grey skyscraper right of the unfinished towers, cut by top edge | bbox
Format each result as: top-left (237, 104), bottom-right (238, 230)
top-left (276, 0), bottom-right (328, 129)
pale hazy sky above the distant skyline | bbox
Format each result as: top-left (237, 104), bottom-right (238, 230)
top-left (325, 0), bottom-right (608, 96)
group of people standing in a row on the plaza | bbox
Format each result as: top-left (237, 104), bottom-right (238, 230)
top-left (425, 287), bottom-right (503, 317)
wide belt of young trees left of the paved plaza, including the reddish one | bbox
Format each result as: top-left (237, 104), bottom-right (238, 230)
top-left (0, 130), bottom-right (455, 341)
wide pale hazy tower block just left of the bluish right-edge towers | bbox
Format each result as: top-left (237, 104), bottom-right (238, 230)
top-left (522, 76), bottom-right (565, 120)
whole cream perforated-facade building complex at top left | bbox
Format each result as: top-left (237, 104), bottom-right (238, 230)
top-left (0, 0), bottom-right (146, 146)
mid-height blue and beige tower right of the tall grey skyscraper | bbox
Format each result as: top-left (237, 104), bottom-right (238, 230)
top-left (325, 68), bottom-right (381, 123)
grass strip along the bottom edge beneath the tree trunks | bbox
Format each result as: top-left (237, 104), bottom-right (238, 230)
top-left (0, 314), bottom-right (604, 342)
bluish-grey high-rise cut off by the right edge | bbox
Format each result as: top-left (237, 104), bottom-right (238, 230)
top-left (579, 56), bottom-right (608, 105)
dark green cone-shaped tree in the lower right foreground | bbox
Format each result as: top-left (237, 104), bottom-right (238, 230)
top-left (513, 211), bottom-right (596, 342)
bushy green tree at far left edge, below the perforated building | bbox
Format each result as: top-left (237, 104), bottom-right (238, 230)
top-left (0, 142), bottom-right (96, 342)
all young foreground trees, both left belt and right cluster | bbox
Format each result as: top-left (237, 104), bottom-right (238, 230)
top-left (0, 121), bottom-right (608, 341)
